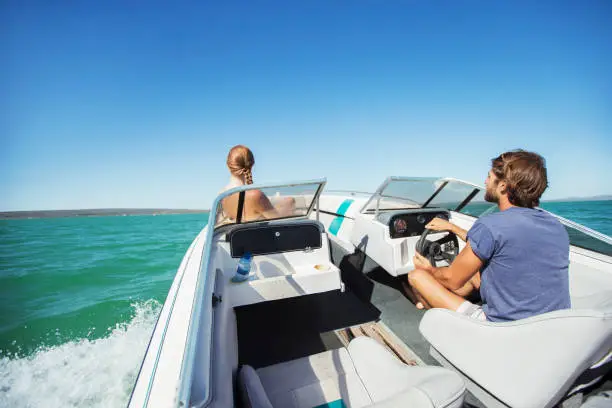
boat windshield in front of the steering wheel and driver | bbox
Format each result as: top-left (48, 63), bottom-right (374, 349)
top-left (361, 177), bottom-right (497, 217)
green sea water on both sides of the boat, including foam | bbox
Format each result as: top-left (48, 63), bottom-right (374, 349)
top-left (0, 201), bottom-right (612, 407)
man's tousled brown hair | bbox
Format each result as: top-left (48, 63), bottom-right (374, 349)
top-left (491, 150), bottom-right (548, 208)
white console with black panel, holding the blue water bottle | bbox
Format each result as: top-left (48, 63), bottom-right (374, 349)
top-left (213, 220), bottom-right (343, 306)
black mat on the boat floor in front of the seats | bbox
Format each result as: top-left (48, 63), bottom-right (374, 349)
top-left (235, 291), bottom-right (380, 368)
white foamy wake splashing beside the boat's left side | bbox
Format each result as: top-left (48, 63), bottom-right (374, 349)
top-left (0, 300), bottom-right (161, 407)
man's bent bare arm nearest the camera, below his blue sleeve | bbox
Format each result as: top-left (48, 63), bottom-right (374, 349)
top-left (415, 242), bottom-right (483, 291)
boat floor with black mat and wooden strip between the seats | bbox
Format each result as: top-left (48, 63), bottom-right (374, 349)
top-left (235, 241), bottom-right (612, 408)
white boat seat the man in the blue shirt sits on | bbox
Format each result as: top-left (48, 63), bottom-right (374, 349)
top-left (419, 308), bottom-right (612, 408)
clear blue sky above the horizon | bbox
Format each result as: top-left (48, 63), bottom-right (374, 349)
top-left (0, 0), bottom-right (612, 210)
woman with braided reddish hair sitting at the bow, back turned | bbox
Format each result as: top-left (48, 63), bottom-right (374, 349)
top-left (221, 145), bottom-right (294, 221)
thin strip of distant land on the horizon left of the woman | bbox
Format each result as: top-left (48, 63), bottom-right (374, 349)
top-left (0, 208), bottom-right (210, 220)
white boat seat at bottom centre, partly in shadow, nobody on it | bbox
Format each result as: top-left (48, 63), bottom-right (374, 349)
top-left (238, 337), bottom-right (465, 408)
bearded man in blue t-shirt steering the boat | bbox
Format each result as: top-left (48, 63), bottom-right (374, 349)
top-left (408, 150), bottom-right (570, 322)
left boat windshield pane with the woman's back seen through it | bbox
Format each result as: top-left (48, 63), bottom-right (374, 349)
top-left (214, 180), bottom-right (325, 228)
